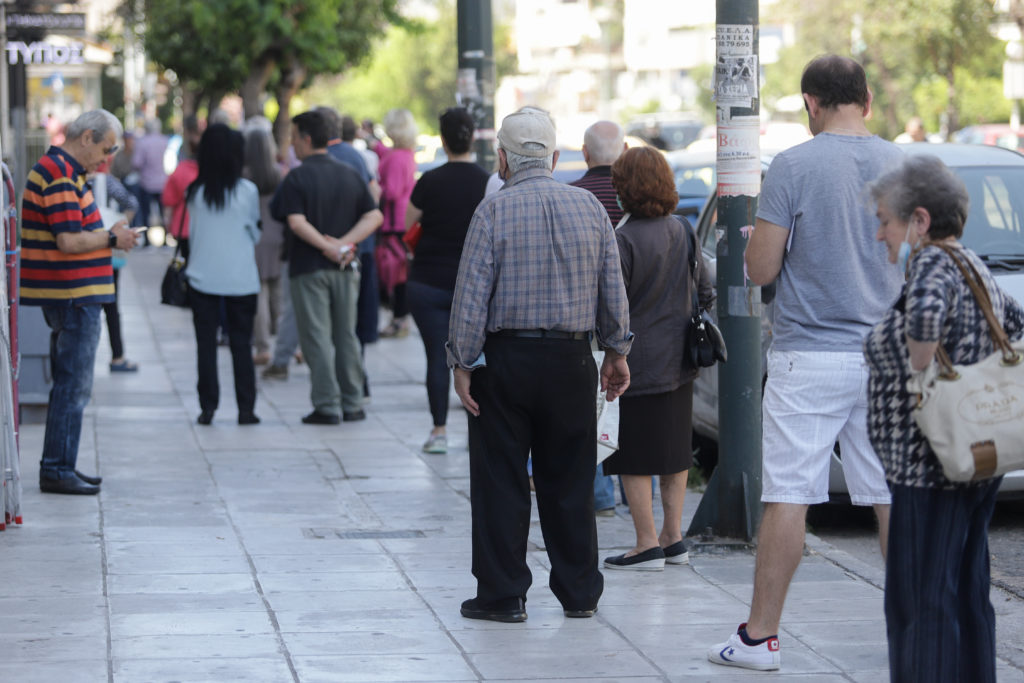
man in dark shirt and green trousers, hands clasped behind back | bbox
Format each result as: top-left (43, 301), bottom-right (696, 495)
top-left (270, 112), bottom-right (383, 425)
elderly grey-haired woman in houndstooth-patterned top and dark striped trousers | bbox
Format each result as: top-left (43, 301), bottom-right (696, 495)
top-left (864, 155), bottom-right (1024, 682)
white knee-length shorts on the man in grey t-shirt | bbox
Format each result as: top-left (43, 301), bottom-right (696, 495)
top-left (761, 350), bottom-right (890, 505)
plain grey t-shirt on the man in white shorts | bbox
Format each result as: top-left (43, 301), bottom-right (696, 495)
top-left (758, 133), bottom-right (903, 352)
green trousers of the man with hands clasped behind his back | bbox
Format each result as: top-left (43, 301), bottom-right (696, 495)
top-left (291, 269), bottom-right (362, 415)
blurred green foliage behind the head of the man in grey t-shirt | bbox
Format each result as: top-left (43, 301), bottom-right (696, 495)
top-left (762, 0), bottom-right (1009, 138)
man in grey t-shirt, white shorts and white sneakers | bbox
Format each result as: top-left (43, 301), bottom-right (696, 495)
top-left (708, 55), bottom-right (902, 670)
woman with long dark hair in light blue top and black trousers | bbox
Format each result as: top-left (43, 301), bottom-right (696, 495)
top-left (185, 124), bottom-right (260, 425)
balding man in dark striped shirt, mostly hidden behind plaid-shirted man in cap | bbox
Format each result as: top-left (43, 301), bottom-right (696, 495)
top-left (569, 121), bottom-right (626, 517)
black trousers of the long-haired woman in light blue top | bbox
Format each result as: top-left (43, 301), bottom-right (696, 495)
top-left (188, 288), bottom-right (256, 415)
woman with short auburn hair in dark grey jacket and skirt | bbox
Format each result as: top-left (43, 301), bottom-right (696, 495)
top-left (604, 147), bottom-right (715, 570)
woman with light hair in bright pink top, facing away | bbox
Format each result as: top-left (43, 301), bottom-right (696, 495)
top-left (374, 110), bottom-right (417, 337)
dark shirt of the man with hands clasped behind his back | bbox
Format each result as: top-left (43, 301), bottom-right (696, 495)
top-left (270, 155), bottom-right (377, 278)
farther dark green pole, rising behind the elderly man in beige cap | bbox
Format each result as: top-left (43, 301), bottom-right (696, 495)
top-left (456, 0), bottom-right (496, 173)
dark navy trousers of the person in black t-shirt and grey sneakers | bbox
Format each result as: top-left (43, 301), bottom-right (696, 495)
top-left (406, 281), bottom-right (455, 427)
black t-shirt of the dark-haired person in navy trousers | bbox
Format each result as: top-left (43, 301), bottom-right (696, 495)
top-left (409, 162), bottom-right (488, 290)
